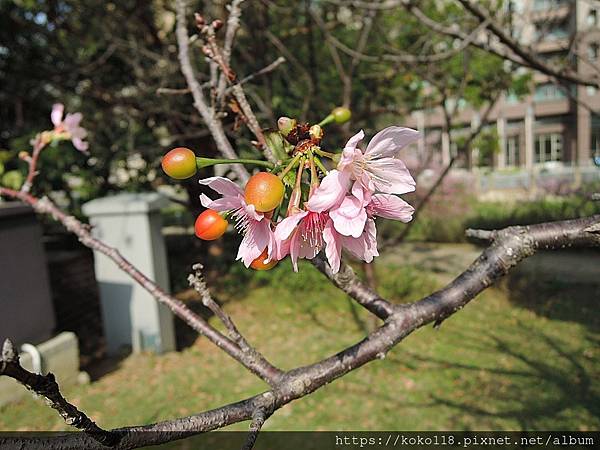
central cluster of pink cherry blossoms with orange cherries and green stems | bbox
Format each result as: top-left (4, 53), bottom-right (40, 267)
top-left (163, 114), bottom-right (419, 273)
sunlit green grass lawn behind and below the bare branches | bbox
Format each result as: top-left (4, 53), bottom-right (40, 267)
top-left (0, 250), bottom-right (600, 430)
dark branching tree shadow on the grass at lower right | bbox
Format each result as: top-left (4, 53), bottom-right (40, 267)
top-left (386, 321), bottom-right (600, 431)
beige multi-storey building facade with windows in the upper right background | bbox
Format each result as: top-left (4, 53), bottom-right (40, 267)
top-left (408, 0), bottom-right (600, 171)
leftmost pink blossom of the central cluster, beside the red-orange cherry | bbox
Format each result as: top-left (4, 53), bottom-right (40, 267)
top-left (200, 177), bottom-right (277, 267)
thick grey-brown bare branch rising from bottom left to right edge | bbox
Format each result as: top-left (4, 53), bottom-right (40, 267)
top-left (2, 215), bottom-right (600, 450)
